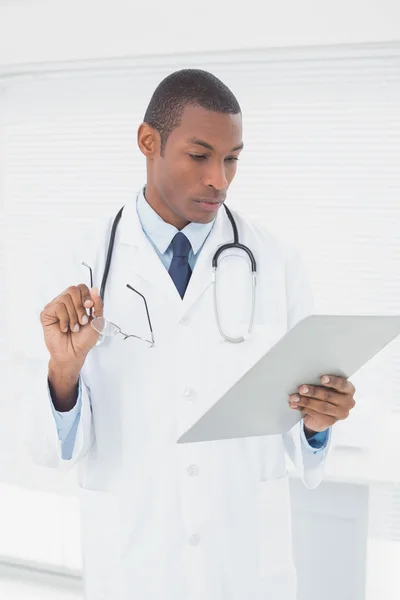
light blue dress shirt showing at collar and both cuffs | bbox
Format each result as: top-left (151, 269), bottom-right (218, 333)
top-left (49, 193), bottom-right (329, 460)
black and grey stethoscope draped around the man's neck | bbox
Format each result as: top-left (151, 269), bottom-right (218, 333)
top-left (100, 204), bottom-right (257, 344)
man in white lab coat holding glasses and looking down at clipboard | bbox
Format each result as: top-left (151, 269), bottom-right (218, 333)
top-left (33, 69), bottom-right (355, 600)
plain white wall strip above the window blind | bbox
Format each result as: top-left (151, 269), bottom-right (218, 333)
top-left (0, 0), bottom-right (400, 67)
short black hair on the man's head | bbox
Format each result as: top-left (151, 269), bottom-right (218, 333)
top-left (144, 69), bottom-right (242, 153)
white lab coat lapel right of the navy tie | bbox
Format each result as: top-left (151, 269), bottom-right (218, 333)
top-left (182, 207), bottom-right (233, 314)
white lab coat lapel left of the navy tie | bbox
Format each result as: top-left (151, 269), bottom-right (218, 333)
top-left (120, 200), bottom-right (181, 303)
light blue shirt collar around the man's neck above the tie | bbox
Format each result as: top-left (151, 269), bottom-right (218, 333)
top-left (137, 189), bottom-right (215, 255)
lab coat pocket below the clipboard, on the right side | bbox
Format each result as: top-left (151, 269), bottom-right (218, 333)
top-left (259, 473), bottom-right (292, 579)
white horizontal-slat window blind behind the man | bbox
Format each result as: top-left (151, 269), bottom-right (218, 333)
top-left (0, 46), bottom-right (400, 572)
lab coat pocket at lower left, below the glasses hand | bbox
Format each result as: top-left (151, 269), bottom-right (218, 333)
top-left (79, 487), bottom-right (123, 600)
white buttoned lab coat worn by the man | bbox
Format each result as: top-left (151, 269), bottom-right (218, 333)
top-left (25, 195), bottom-right (328, 600)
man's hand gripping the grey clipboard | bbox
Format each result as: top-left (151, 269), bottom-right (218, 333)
top-left (289, 375), bottom-right (356, 434)
